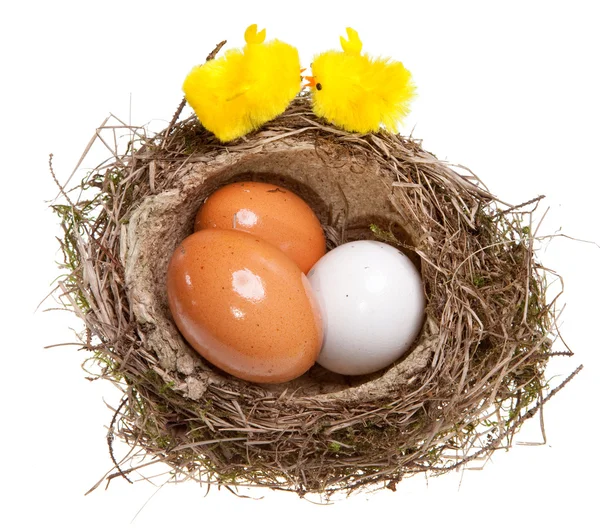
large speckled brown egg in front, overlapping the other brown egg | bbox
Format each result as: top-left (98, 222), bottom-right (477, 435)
top-left (167, 229), bottom-right (323, 383)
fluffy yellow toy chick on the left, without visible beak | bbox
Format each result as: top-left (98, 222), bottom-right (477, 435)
top-left (183, 24), bottom-right (301, 142)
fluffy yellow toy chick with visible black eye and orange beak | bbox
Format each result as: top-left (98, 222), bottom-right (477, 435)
top-left (305, 28), bottom-right (415, 134)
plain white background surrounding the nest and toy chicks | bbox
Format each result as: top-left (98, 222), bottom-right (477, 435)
top-left (0, 0), bottom-right (600, 528)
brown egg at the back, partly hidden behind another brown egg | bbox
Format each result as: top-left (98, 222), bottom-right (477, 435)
top-left (194, 182), bottom-right (325, 274)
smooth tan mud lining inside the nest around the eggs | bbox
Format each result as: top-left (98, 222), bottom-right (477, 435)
top-left (122, 134), bottom-right (431, 401)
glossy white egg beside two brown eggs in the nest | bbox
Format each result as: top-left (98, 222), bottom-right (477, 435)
top-left (308, 241), bottom-right (425, 375)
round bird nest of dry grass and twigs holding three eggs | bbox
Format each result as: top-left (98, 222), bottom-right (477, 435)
top-left (53, 95), bottom-right (573, 496)
